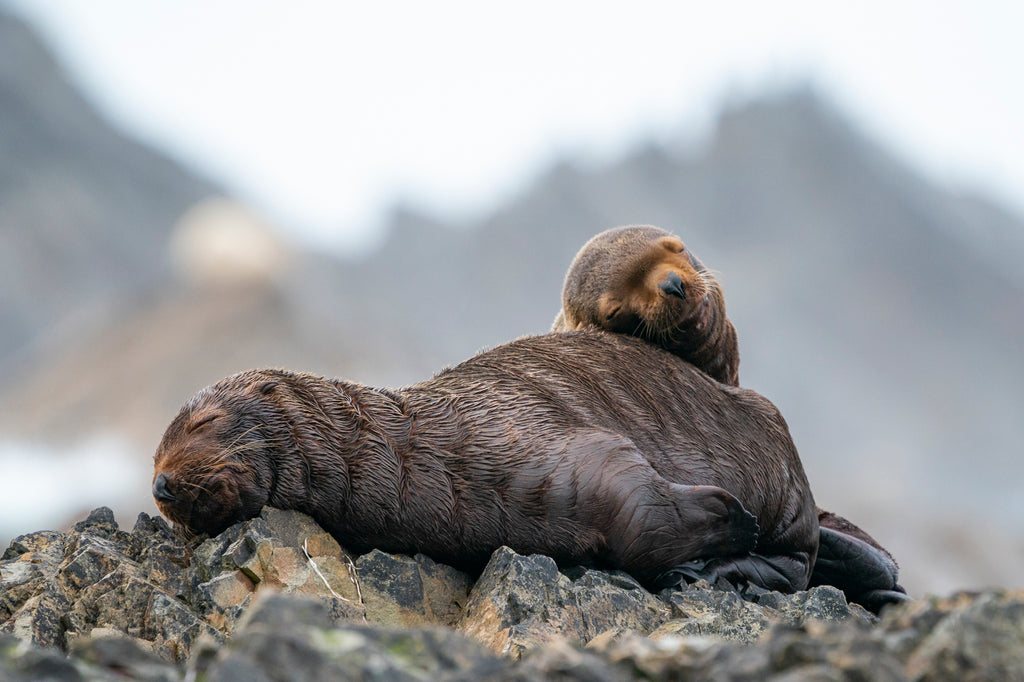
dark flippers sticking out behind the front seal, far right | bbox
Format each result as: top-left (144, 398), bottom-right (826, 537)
top-left (811, 526), bottom-right (910, 613)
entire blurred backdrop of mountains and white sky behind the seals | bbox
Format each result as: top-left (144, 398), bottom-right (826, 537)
top-left (0, 0), bottom-right (1024, 595)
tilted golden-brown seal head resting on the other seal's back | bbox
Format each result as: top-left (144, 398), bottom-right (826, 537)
top-left (551, 225), bottom-right (739, 386)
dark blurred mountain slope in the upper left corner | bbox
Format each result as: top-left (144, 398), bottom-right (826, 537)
top-left (0, 9), bottom-right (216, 372)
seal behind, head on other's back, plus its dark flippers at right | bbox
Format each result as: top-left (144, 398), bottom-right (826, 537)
top-left (552, 225), bottom-right (906, 611)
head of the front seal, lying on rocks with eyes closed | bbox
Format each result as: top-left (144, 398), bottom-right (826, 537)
top-left (153, 371), bottom-right (280, 535)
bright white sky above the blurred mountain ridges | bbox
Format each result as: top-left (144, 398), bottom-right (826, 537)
top-left (8, 0), bottom-right (1024, 248)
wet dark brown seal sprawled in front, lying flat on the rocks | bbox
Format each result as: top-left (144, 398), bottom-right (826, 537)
top-left (153, 331), bottom-right (818, 592)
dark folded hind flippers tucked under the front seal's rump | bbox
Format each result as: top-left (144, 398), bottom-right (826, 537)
top-left (656, 552), bottom-right (809, 593)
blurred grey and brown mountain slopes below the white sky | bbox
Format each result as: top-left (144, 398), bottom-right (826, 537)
top-left (0, 3), bottom-right (1024, 592)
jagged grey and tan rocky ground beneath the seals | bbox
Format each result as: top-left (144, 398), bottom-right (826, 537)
top-left (0, 501), bottom-right (1024, 681)
